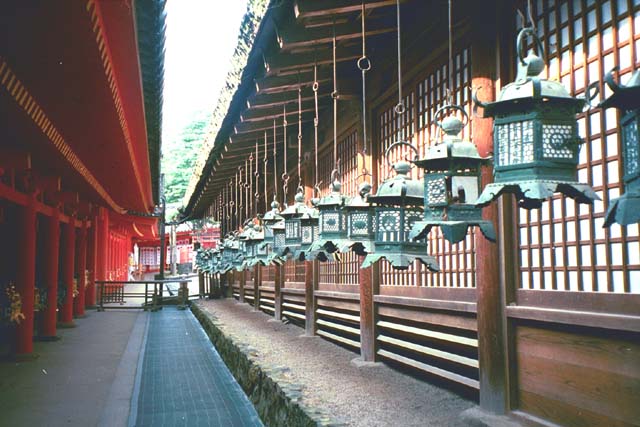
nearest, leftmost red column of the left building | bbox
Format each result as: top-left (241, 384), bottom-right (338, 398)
top-left (16, 195), bottom-right (36, 356)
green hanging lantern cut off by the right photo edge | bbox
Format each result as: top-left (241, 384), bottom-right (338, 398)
top-left (600, 69), bottom-right (640, 227)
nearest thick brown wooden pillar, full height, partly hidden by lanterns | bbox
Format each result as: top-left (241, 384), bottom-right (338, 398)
top-left (471, 0), bottom-right (510, 414)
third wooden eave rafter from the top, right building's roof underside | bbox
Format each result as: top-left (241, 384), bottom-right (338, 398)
top-left (264, 44), bottom-right (362, 77)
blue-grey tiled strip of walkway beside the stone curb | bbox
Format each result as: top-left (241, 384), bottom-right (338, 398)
top-left (129, 307), bottom-right (262, 427)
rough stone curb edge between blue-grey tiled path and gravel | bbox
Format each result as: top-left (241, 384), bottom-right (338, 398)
top-left (191, 302), bottom-right (346, 427)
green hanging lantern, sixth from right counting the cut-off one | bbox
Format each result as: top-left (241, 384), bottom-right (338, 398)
top-left (307, 170), bottom-right (348, 261)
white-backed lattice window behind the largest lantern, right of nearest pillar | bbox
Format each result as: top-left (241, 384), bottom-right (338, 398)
top-left (518, 0), bottom-right (640, 293)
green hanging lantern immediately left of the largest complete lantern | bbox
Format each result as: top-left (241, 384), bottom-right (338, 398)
top-left (409, 105), bottom-right (496, 243)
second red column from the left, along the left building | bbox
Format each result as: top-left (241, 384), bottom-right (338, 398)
top-left (42, 209), bottom-right (60, 339)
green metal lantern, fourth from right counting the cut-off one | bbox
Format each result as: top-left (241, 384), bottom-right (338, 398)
top-left (361, 141), bottom-right (440, 271)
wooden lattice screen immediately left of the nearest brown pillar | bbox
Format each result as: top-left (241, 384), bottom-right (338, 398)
top-left (377, 47), bottom-right (475, 287)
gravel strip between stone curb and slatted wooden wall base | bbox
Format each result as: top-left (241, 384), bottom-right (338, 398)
top-left (198, 300), bottom-right (474, 427)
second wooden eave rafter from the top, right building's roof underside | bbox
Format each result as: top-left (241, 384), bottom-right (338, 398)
top-left (278, 21), bottom-right (396, 51)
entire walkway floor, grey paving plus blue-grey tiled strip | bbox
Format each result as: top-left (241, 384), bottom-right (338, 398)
top-left (0, 307), bottom-right (262, 427)
